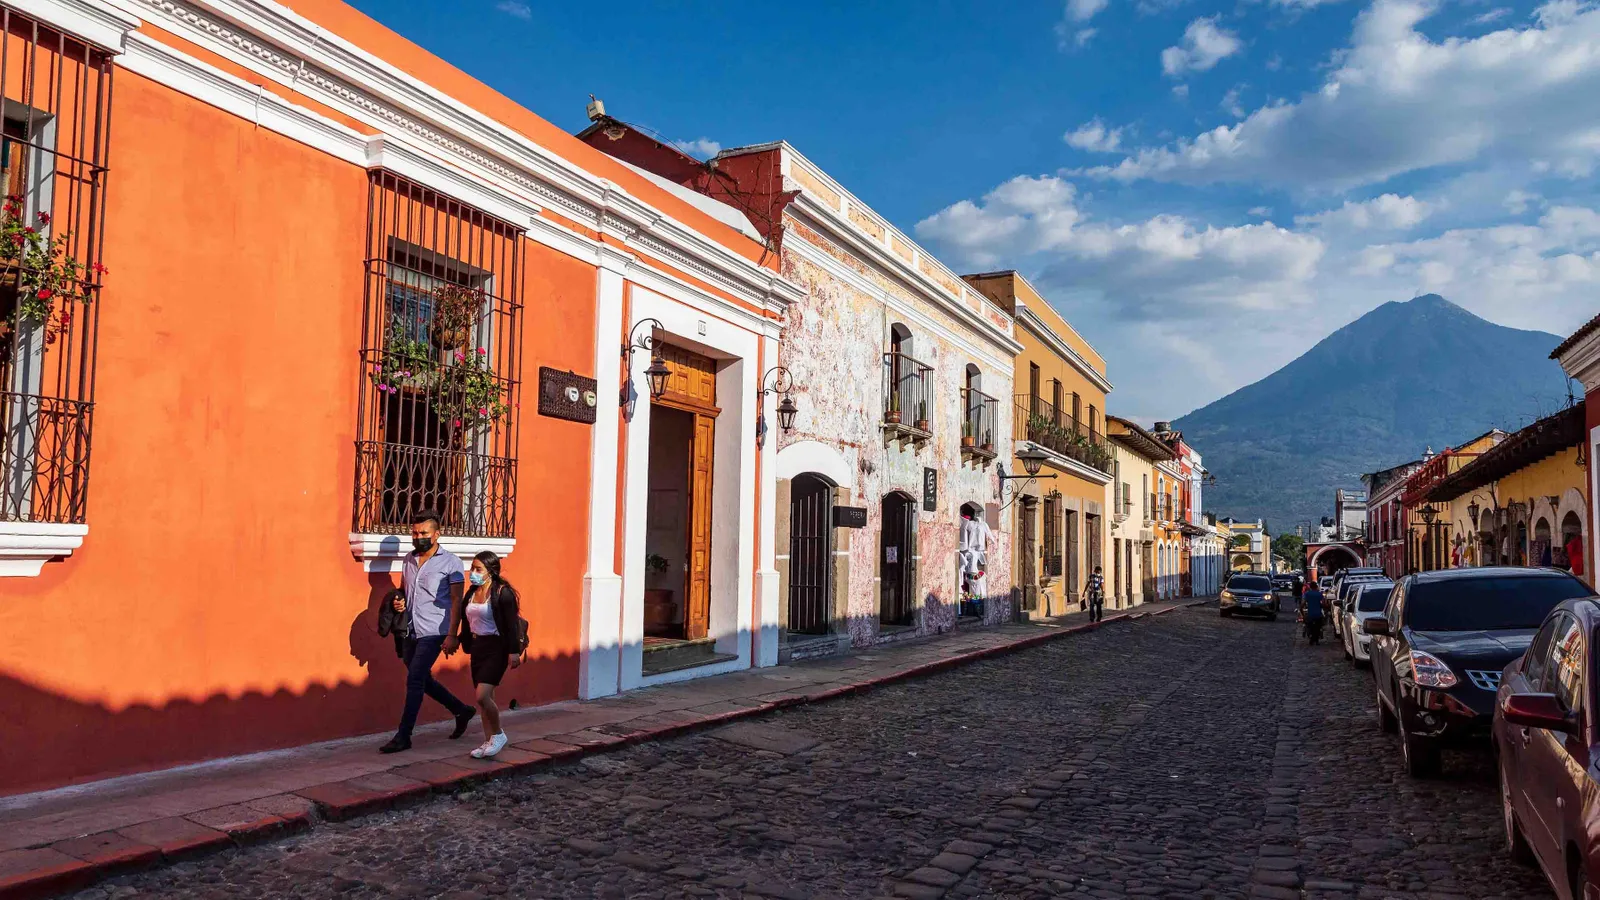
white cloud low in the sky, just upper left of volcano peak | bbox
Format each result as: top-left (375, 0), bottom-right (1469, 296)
top-left (917, 176), bottom-right (1323, 319)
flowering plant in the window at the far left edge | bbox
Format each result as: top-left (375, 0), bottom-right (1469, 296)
top-left (0, 194), bottom-right (106, 343)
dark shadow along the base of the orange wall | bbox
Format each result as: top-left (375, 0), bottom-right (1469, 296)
top-left (0, 573), bottom-right (578, 794)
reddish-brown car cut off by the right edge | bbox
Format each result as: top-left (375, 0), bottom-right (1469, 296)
top-left (1493, 597), bottom-right (1600, 900)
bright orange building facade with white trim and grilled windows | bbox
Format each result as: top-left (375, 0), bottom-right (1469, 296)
top-left (0, 0), bottom-right (800, 791)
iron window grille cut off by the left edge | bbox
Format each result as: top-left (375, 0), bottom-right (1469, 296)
top-left (0, 6), bottom-right (112, 524)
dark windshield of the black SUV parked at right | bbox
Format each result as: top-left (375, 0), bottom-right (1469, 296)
top-left (1405, 575), bottom-right (1590, 631)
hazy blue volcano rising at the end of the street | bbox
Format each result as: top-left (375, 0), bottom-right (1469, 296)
top-left (1173, 293), bottom-right (1566, 533)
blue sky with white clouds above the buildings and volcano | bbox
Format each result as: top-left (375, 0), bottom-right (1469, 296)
top-left (340, 0), bottom-right (1600, 421)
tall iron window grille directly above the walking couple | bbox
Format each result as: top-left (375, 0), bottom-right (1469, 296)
top-left (354, 170), bottom-right (523, 538)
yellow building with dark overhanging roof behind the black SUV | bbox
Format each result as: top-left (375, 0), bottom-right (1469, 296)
top-left (1426, 402), bottom-right (1594, 573)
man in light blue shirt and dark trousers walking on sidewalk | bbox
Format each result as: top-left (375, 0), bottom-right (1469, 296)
top-left (378, 512), bottom-right (475, 753)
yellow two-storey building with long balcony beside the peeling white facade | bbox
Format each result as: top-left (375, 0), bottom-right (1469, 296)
top-left (963, 271), bottom-right (1126, 617)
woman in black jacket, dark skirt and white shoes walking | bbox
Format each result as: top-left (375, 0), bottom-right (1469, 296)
top-left (461, 551), bottom-right (528, 759)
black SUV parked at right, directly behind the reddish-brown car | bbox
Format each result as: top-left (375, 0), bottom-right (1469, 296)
top-left (1363, 565), bottom-right (1590, 777)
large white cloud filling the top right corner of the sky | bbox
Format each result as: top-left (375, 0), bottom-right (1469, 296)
top-left (1088, 0), bottom-right (1600, 191)
